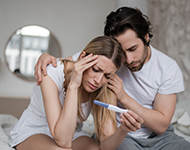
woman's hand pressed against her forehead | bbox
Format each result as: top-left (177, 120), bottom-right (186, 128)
top-left (69, 54), bottom-right (98, 88)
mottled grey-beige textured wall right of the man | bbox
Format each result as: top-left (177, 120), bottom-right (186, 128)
top-left (149, 0), bottom-right (190, 101)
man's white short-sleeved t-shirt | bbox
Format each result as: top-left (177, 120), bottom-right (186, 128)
top-left (73, 46), bottom-right (184, 138)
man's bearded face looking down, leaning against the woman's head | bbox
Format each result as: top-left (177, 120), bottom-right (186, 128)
top-left (115, 29), bottom-right (151, 72)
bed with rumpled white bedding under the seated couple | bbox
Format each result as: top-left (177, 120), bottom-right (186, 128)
top-left (0, 100), bottom-right (190, 150)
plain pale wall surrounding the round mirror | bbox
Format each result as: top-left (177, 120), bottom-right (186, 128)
top-left (0, 0), bottom-right (116, 97)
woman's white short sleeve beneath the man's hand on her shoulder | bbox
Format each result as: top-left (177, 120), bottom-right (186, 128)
top-left (47, 59), bottom-right (65, 91)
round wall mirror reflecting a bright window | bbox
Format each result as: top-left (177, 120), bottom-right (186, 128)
top-left (5, 25), bottom-right (61, 81)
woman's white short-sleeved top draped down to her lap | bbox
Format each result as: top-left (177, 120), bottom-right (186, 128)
top-left (10, 60), bottom-right (91, 147)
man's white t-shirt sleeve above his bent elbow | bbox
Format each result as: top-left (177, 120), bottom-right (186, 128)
top-left (158, 62), bottom-right (184, 94)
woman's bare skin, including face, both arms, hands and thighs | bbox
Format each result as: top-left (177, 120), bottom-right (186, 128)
top-left (16, 52), bottom-right (143, 150)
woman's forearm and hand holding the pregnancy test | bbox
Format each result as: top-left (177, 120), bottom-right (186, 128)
top-left (100, 110), bottom-right (143, 150)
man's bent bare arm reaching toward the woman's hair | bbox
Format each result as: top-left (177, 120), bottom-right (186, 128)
top-left (108, 75), bottom-right (176, 134)
